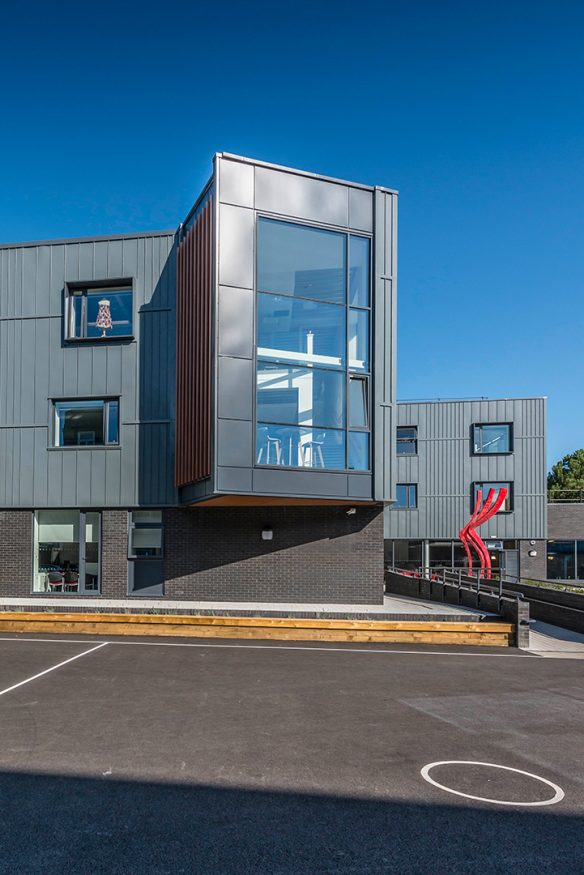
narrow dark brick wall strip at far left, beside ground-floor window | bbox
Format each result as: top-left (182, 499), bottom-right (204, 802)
top-left (0, 510), bottom-right (33, 598)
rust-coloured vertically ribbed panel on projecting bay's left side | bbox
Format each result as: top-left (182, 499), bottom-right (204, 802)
top-left (175, 198), bottom-right (213, 486)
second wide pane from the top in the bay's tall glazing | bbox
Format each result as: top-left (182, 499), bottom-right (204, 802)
top-left (257, 294), bottom-right (346, 368)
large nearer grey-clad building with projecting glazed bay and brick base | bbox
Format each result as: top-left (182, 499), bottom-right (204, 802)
top-left (0, 154), bottom-right (397, 603)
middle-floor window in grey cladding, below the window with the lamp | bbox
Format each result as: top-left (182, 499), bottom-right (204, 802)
top-left (55, 398), bottom-right (120, 447)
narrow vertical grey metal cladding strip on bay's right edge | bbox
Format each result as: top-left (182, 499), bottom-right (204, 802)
top-left (372, 189), bottom-right (397, 501)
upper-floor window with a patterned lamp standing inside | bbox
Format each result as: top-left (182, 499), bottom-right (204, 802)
top-left (65, 280), bottom-right (133, 341)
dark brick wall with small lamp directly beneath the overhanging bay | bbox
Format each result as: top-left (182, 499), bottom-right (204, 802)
top-left (164, 506), bottom-right (384, 604)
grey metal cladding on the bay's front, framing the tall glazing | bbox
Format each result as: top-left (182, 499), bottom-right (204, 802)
top-left (214, 155), bottom-right (388, 500)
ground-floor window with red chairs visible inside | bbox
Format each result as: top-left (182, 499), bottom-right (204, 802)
top-left (33, 510), bottom-right (101, 593)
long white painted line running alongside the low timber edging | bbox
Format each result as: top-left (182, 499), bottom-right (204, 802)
top-left (0, 636), bottom-right (541, 659)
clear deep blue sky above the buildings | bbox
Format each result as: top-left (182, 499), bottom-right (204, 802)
top-left (0, 0), bottom-right (584, 463)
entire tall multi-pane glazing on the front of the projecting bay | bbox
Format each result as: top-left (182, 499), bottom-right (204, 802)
top-left (255, 217), bottom-right (371, 471)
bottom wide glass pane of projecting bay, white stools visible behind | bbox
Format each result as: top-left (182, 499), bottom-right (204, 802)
top-left (256, 422), bottom-right (345, 470)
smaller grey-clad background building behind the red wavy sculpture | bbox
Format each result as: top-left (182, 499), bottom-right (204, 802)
top-left (385, 398), bottom-right (584, 580)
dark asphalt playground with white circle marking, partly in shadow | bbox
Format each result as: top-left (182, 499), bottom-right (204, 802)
top-left (0, 635), bottom-right (584, 875)
